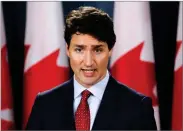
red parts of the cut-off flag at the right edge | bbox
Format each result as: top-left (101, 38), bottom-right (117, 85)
top-left (172, 41), bottom-right (183, 130)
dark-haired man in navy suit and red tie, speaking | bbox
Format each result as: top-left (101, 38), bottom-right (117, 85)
top-left (26, 7), bottom-right (156, 130)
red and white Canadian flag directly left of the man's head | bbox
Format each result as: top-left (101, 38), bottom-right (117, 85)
top-left (23, 2), bottom-right (69, 127)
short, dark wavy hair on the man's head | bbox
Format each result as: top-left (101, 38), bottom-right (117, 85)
top-left (64, 6), bottom-right (116, 50)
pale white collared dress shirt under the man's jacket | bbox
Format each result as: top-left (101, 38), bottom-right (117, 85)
top-left (73, 71), bottom-right (109, 130)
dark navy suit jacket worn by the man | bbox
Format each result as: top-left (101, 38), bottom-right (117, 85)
top-left (26, 76), bottom-right (156, 130)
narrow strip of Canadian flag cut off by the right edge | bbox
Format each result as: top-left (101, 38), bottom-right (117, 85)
top-left (172, 2), bottom-right (183, 130)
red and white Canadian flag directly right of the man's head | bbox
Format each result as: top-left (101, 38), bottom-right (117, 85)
top-left (110, 2), bottom-right (160, 130)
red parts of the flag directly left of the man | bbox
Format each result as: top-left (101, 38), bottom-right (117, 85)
top-left (24, 46), bottom-right (69, 127)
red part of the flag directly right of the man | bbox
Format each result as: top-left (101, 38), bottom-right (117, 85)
top-left (111, 42), bottom-right (158, 105)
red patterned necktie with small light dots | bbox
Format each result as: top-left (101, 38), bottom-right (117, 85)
top-left (75, 90), bottom-right (91, 130)
